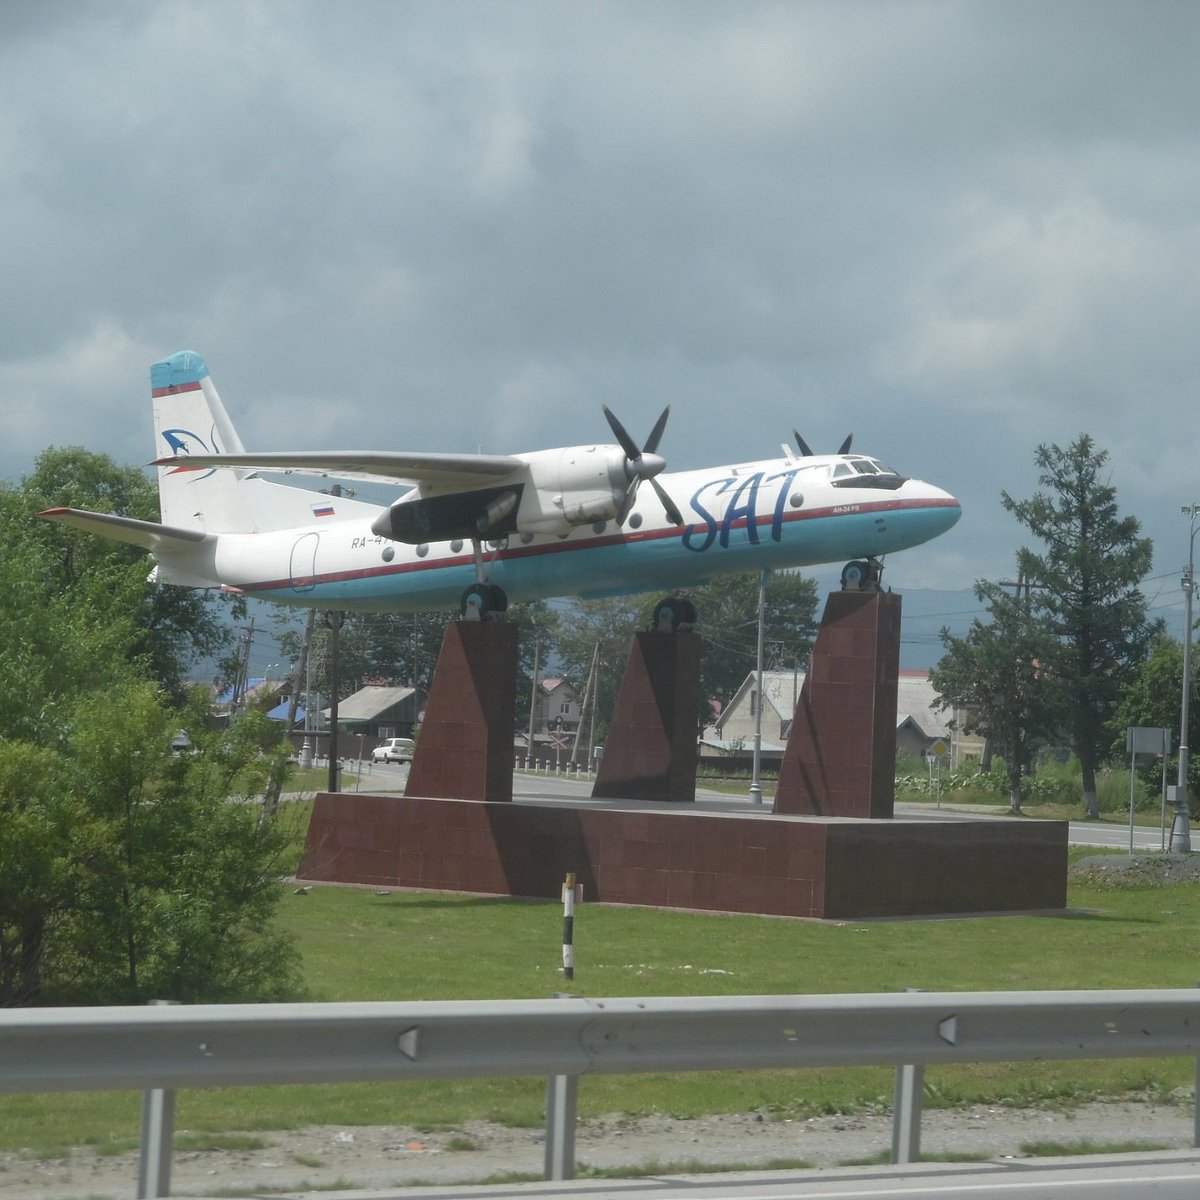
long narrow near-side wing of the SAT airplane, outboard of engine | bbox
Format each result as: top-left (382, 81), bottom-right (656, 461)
top-left (151, 450), bottom-right (526, 486)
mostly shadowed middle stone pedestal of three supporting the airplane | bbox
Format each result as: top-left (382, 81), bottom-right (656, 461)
top-left (592, 632), bottom-right (700, 802)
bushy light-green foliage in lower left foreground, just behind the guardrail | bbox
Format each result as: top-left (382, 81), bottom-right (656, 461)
top-left (0, 680), bottom-right (298, 1004)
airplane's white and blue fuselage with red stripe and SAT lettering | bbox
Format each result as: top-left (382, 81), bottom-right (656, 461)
top-left (158, 456), bottom-right (960, 611)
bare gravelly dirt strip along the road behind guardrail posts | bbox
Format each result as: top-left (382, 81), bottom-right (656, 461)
top-left (0, 1102), bottom-right (1193, 1200)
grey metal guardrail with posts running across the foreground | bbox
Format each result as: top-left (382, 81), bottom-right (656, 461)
top-left (0, 989), bottom-right (1200, 1196)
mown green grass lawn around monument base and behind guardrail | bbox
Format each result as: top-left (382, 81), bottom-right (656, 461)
top-left (0, 844), bottom-right (1200, 1150)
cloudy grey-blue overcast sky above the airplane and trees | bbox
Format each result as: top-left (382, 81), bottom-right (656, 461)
top-left (0, 0), bottom-right (1200, 648)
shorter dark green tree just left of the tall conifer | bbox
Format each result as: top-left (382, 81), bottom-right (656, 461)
top-left (930, 581), bottom-right (1062, 812)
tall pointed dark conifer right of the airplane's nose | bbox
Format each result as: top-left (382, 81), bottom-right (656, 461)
top-left (1001, 433), bottom-right (1157, 817)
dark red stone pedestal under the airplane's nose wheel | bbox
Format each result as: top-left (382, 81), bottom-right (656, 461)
top-left (775, 592), bottom-right (900, 817)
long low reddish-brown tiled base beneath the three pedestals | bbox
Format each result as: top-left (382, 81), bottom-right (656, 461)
top-left (298, 792), bottom-right (1067, 919)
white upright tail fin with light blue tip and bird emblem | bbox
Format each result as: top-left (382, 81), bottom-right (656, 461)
top-left (150, 350), bottom-right (378, 533)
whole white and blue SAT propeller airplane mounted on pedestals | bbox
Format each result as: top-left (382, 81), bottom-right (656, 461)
top-left (32, 350), bottom-right (961, 629)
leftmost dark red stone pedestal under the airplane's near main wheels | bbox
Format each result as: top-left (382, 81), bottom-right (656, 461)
top-left (404, 620), bottom-right (517, 802)
